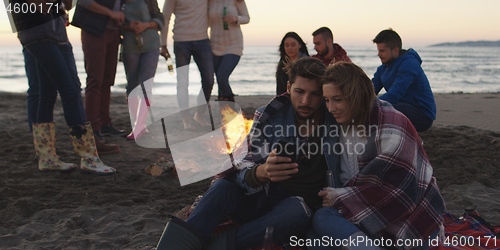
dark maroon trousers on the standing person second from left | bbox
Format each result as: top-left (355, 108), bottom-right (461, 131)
top-left (82, 29), bottom-right (120, 130)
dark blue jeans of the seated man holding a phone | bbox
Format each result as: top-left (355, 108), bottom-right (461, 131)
top-left (187, 179), bottom-right (311, 249)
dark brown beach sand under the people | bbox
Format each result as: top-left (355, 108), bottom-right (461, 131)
top-left (0, 93), bottom-right (500, 249)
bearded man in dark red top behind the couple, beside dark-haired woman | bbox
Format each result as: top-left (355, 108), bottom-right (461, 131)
top-left (312, 27), bottom-right (351, 66)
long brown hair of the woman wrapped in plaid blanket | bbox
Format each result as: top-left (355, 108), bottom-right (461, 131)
top-left (323, 62), bottom-right (375, 126)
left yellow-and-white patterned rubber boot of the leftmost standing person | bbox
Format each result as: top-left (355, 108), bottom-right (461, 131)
top-left (33, 122), bottom-right (77, 172)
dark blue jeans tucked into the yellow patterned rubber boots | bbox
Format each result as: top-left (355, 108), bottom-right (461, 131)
top-left (23, 41), bottom-right (86, 126)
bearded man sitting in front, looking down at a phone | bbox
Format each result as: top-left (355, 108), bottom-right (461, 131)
top-left (148, 57), bottom-right (340, 250)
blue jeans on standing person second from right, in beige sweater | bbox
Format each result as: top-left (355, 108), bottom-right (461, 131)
top-left (174, 39), bottom-right (214, 116)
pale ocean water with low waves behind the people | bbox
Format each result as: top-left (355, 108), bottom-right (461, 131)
top-left (0, 45), bottom-right (500, 95)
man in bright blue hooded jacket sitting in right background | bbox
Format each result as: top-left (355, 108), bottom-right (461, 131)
top-left (372, 29), bottom-right (436, 132)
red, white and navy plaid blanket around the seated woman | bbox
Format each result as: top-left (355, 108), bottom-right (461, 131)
top-left (333, 100), bottom-right (445, 248)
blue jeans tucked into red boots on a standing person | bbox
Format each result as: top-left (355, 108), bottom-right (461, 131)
top-left (123, 50), bottom-right (160, 96)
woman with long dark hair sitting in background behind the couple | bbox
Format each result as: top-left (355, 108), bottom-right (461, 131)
top-left (276, 31), bottom-right (309, 95)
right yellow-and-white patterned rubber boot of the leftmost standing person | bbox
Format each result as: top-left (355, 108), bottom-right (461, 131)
top-left (69, 122), bottom-right (116, 175)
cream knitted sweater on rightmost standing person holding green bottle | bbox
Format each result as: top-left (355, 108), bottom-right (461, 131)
top-left (208, 0), bottom-right (250, 56)
